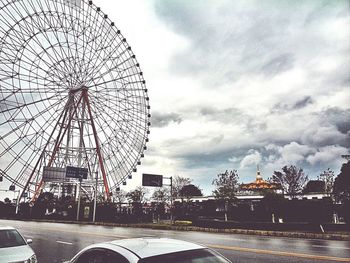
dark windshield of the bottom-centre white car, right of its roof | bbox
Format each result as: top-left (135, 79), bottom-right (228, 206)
top-left (139, 249), bottom-right (229, 263)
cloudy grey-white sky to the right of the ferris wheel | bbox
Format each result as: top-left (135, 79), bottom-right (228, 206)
top-left (94, 0), bottom-right (350, 194)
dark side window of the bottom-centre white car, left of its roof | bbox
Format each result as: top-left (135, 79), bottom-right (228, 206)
top-left (75, 249), bottom-right (129, 263)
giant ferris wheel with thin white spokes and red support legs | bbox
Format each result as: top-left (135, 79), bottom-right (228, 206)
top-left (0, 0), bottom-right (151, 200)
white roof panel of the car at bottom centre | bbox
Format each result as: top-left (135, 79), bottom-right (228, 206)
top-left (109, 238), bottom-right (204, 258)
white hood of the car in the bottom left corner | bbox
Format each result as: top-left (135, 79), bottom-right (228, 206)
top-left (0, 245), bottom-right (34, 262)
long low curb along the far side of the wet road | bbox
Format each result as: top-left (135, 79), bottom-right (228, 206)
top-left (2, 219), bottom-right (350, 241)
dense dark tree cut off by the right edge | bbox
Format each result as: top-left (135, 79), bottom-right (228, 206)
top-left (334, 161), bottom-right (350, 203)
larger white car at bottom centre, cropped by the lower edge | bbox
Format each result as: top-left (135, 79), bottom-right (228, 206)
top-left (68, 238), bottom-right (230, 263)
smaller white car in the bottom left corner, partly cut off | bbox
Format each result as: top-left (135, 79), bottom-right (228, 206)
top-left (0, 226), bottom-right (37, 263)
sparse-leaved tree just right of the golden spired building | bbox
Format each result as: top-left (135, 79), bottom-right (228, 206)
top-left (269, 165), bottom-right (309, 197)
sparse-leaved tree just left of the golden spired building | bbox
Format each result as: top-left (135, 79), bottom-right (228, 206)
top-left (212, 170), bottom-right (239, 201)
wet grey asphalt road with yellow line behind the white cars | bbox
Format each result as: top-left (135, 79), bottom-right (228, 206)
top-left (0, 220), bottom-right (350, 263)
